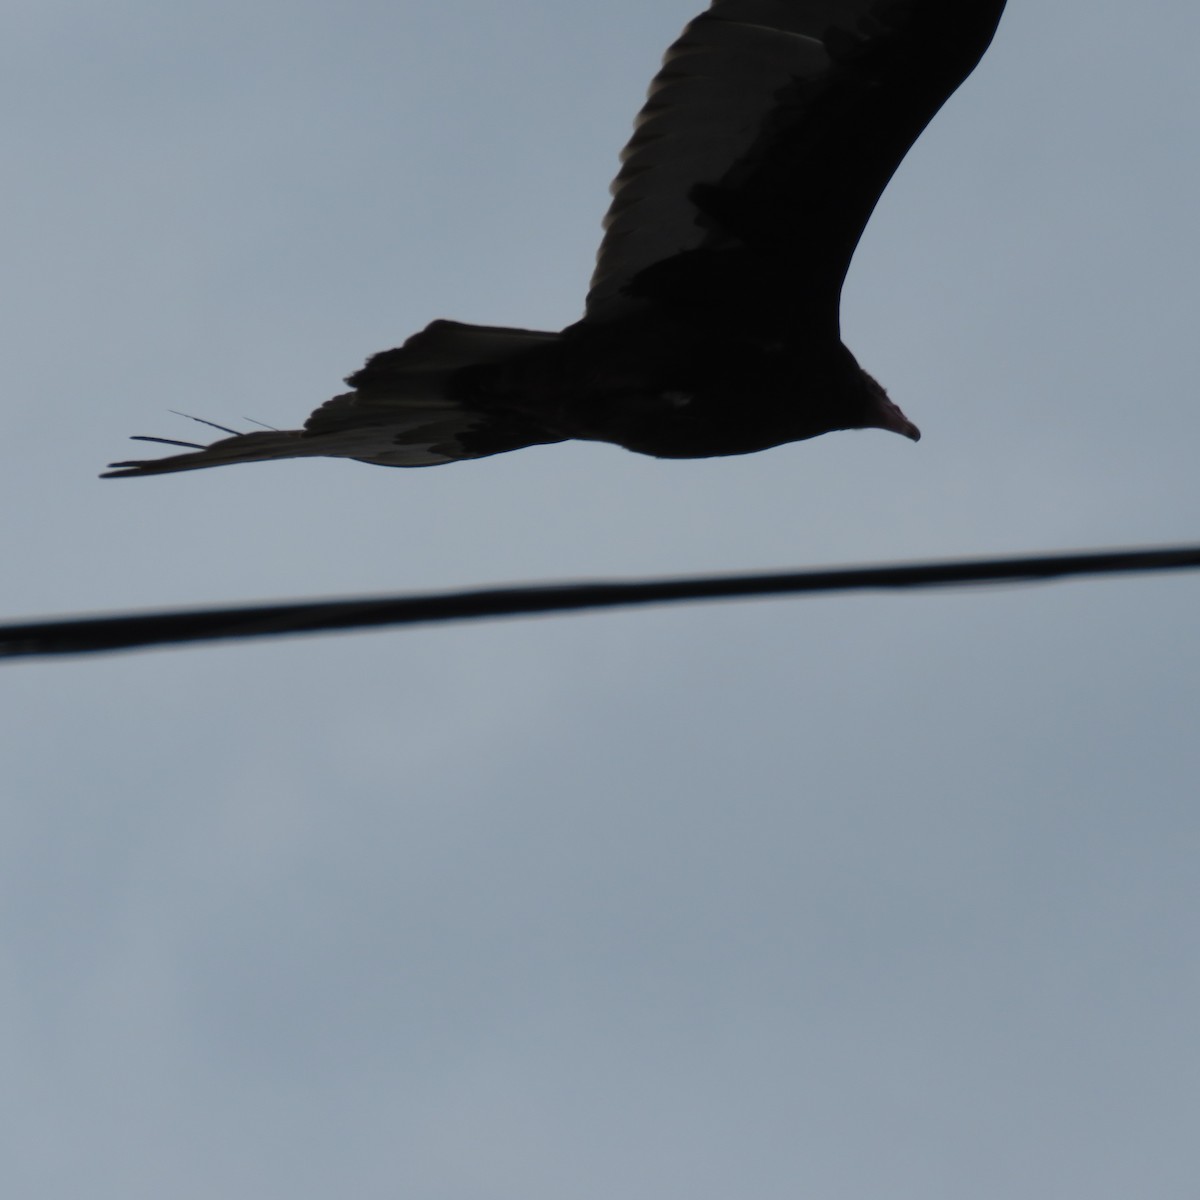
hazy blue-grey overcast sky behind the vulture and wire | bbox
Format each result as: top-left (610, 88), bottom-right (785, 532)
top-left (0, 0), bottom-right (1200, 1200)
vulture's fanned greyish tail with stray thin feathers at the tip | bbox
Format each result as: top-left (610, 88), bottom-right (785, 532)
top-left (102, 320), bottom-right (560, 479)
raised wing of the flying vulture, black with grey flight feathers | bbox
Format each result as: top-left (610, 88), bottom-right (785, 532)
top-left (586, 0), bottom-right (1004, 320)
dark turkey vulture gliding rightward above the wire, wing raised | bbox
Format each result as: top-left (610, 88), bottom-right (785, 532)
top-left (109, 0), bottom-right (1006, 475)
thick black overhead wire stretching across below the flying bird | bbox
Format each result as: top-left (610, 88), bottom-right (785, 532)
top-left (0, 546), bottom-right (1200, 658)
